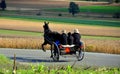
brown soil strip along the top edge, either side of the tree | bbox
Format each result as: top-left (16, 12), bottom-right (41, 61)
top-left (7, 0), bottom-right (108, 9)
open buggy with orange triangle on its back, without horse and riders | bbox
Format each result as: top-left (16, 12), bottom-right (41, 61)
top-left (52, 41), bottom-right (85, 61)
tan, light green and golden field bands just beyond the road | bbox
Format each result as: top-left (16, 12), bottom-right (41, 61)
top-left (0, 17), bottom-right (120, 54)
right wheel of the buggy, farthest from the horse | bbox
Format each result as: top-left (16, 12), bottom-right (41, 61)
top-left (76, 42), bottom-right (85, 61)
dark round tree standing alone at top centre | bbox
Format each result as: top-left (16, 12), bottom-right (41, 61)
top-left (69, 2), bottom-right (79, 16)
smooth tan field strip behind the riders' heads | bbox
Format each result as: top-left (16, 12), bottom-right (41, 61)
top-left (0, 18), bottom-right (120, 37)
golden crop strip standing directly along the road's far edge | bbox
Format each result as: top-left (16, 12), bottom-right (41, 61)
top-left (0, 37), bottom-right (120, 54)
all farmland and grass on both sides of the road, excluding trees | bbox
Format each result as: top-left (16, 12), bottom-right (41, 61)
top-left (0, 0), bottom-right (120, 74)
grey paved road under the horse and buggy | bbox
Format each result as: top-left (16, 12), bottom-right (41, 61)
top-left (0, 48), bottom-right (120, 67)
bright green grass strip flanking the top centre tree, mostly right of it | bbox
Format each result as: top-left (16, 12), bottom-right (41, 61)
top-left (46, 5), bottom-right (120, 14)
